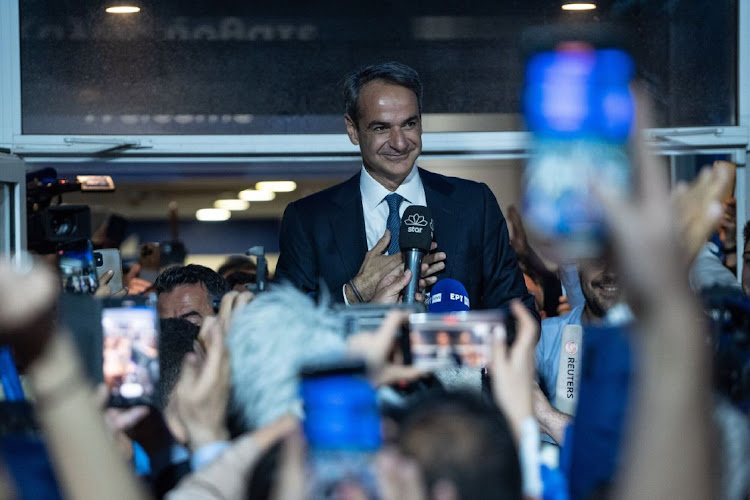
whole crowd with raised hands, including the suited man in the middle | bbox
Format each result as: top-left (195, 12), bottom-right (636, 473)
top-left (0, 63), bottom-right (750, 500)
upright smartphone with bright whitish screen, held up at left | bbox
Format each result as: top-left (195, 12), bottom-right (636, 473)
top-left (102, 298), bottom-right (159, 406)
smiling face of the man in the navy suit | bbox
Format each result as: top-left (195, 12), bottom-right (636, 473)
top-left (346, 80), bottom-right (422, 191)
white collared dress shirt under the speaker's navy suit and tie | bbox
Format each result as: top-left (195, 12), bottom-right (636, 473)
top-left (359, 164), bottom-right (427, 250)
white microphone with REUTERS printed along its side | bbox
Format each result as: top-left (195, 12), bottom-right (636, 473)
top-left (555, 325), bottom-right (583, 415)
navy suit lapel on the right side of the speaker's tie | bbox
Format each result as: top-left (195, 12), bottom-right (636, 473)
top-left (419, 168), bottom-right (464, 275)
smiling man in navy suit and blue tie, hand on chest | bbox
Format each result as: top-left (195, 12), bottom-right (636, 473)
top-left (276, 62), bottom-right (534, 311)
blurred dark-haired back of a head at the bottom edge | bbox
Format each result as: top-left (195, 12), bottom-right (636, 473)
top-left (398, 392), bottom-right (521, 500)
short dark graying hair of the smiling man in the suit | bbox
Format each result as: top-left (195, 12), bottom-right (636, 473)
top-left (344, 61), bottom-right (422, 127)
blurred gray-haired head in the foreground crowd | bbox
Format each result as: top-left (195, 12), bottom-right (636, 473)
top-left (227, 285), bottom-right (346, 429)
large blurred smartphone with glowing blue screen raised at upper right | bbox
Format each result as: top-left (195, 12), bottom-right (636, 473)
top-left (522, 34), bottom-right (635, 261)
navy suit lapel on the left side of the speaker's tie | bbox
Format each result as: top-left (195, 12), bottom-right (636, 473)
top-left (330, 174), bottom-right (367, 279)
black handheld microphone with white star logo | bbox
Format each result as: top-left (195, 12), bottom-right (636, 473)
top-left (398, 205), bottom-right (433, 304)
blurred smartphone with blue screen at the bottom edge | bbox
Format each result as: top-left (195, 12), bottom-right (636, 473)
top-left (300, 361), bottom-right (382, 499)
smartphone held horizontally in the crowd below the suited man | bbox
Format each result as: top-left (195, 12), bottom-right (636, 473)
top-left (402, 311), bottom-right (506, 370)
